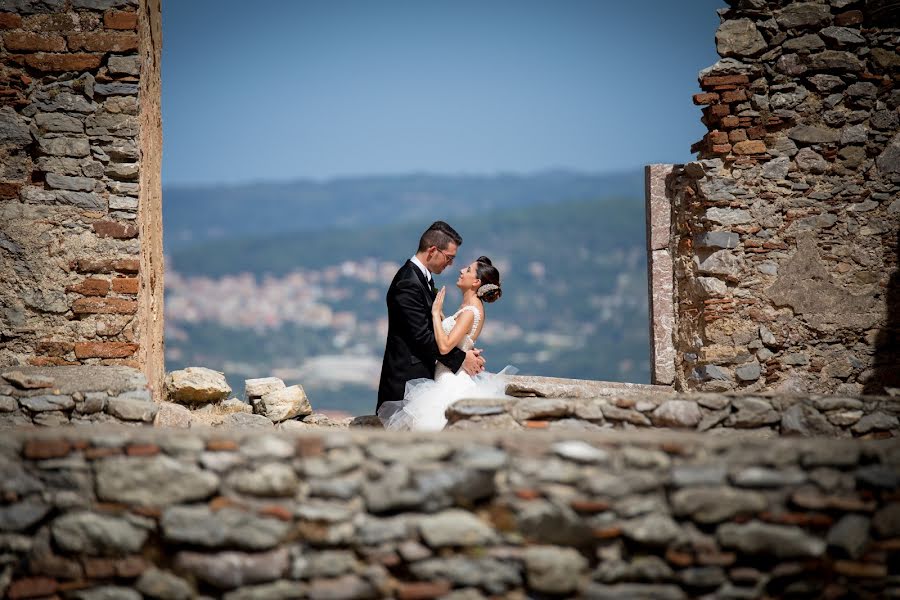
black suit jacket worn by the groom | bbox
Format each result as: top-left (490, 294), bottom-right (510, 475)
top-left (376, 260), bottom-right (466, 410)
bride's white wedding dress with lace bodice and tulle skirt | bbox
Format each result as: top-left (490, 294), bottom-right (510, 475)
top-left (378, 305), bottom-right (516, 431)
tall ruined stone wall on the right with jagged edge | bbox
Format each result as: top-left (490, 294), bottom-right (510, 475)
top-left (665, 0), bottom-right (900, 394)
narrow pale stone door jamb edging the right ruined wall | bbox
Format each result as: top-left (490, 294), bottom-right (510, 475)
top-left (644, 165), bottom-right (675, 385)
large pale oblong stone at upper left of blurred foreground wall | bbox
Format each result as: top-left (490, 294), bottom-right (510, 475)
top-left (95, 456), bottom-right (219, 507)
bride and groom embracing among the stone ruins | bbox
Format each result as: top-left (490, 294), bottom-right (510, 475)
top-left (377, 221), bottom-right (505, 431)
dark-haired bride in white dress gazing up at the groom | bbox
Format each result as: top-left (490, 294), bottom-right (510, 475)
top-left (378, 256), bottom-right (510, 431)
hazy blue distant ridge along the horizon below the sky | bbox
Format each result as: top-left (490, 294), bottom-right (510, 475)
top-left (163, 170), bottom-right (643, 253)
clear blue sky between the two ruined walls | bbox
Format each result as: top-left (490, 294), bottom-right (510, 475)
top-left (162, 0), bottom-right (724, 185)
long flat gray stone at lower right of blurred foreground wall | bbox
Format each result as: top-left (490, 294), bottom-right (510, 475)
top-left (716, 521), bottom-right (825, 558)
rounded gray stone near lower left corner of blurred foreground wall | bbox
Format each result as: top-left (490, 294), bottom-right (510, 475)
top-left (50, 512), bottom-right (147, 556)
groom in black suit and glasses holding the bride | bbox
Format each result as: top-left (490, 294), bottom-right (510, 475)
top-left (375, 221), bottom-right (484, 411)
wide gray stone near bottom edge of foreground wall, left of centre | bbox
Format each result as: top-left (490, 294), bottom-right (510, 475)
top-left (175, 548), bottom-right (289, 589)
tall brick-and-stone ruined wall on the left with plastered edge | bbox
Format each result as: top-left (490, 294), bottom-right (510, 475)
top-left (0, 0), bottom-right (163, 400)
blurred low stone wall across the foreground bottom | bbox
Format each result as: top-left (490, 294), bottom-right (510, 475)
top-left (0, 426), bottom-right (900, 599)
